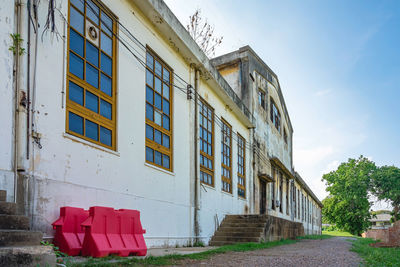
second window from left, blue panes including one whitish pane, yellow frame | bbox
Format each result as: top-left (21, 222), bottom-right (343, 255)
top-left (145, 49), bottom-right (172, 171)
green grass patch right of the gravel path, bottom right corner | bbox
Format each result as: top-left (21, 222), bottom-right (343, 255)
top-left (351, 237), bottom-right (400, 267)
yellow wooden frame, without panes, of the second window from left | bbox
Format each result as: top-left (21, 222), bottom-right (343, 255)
top-left (144, 46), bottom-right (174, 172)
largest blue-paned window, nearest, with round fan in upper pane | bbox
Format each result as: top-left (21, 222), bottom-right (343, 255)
top-left (66, 0), bottom-right (117, 150)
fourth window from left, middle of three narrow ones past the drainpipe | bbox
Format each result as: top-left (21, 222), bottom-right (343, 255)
top-left (221, 120), bottom-right (232, 193)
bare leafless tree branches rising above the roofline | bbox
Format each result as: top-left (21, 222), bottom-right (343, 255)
top-left (186, 9), bottom-right (223, 57)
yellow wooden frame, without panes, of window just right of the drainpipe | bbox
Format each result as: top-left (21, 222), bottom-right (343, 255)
top-left (196, 97), bottom-right (215, 187)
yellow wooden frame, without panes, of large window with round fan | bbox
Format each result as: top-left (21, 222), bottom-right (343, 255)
top-left (65, 0), bottom-right (118, 151)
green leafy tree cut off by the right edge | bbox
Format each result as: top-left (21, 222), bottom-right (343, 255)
top-left (371, 166), bottom-right (400, 221)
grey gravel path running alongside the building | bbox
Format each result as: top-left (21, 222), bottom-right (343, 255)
top-left (173, 237), bottom-right (361, 267)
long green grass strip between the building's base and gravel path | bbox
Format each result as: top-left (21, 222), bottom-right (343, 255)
top-left (67, 239), bottom-right (297, 267)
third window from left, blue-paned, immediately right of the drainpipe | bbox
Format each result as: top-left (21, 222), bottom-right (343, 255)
top-left (199, 99), bottom-right (214, 186)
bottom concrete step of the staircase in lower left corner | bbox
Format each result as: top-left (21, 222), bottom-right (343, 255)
top-left (0, 246), bottom-right (57, 267)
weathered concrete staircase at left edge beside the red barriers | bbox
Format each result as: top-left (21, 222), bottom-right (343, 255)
top-left (0, 190), bottom-right (56, 266)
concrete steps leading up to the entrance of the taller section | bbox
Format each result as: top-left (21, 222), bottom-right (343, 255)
top-left (209, 215), bottom-right (268, 246)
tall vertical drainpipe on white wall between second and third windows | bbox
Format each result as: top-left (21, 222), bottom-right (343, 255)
top-left (194, 69), bottom-right (200, 243)
